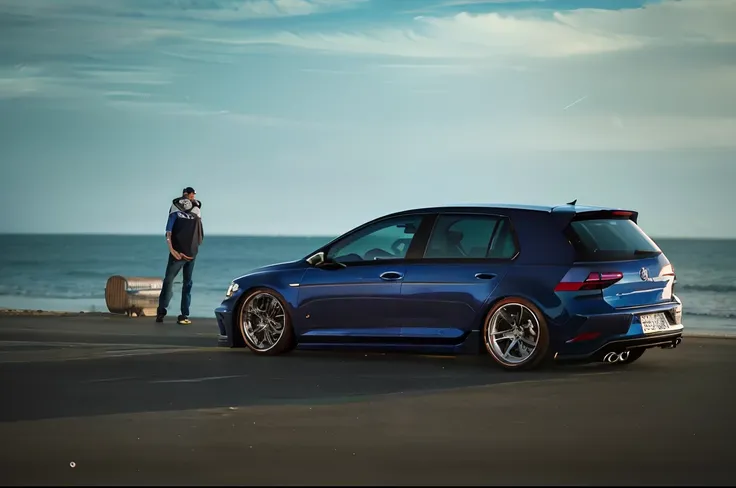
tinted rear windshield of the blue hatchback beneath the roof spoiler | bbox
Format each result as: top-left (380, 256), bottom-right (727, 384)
top-left (569, 219), bottom-right (662, 261)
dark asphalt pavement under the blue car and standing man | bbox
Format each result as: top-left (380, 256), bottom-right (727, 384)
top-left (0, 316), bottom-right (736, 486)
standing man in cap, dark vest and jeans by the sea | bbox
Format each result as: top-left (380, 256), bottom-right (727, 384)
top-left (156, 186), bottom-right (204, 325)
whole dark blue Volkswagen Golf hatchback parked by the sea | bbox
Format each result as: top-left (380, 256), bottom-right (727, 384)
top-left (215, 202), bottom-right (683, 370)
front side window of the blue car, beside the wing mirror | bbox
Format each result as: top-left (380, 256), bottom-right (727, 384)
top-left (327, 215), bottom-right (423, 263)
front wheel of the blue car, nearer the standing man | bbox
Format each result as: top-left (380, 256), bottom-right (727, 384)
top-left (236, 288), bottom-right (296, 356)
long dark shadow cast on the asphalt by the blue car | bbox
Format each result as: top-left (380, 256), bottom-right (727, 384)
top-left (0, 348), bottom-right (616, 422)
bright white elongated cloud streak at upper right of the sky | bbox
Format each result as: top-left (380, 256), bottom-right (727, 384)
top-left (207, 0), bottom-right (736, 58)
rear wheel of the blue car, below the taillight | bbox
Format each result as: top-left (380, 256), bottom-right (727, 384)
top-left (482, 297), bottom-right (549, 371)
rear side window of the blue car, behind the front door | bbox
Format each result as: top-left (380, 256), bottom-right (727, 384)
top-left (424, 215), bottom-right (516, 259)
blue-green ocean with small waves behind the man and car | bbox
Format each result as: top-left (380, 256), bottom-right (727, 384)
top-left (0, 235), bottom-right (736, 332)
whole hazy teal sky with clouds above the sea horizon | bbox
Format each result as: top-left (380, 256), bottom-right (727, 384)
top-left (0, 0), bottom-right (736, 237)
